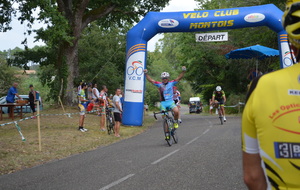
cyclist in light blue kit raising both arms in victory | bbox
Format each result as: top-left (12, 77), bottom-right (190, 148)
top-left (144, 66), bottom-right (186, 129)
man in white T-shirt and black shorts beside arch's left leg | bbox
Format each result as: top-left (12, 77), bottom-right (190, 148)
top-left (113, 88), bottom-right (123, 137)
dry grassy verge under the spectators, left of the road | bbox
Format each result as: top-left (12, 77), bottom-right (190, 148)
top-left (0, 108), bottom-right (155, 175)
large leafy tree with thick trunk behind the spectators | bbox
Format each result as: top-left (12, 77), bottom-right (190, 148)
top-left (0, 0), bottom-right (169, 104)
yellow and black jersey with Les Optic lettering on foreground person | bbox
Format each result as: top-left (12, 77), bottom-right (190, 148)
top-left (242, 64), bottom-right (300, 190)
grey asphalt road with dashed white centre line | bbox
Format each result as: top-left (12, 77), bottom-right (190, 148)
top-left (0, 106), bottom-right (246, 190)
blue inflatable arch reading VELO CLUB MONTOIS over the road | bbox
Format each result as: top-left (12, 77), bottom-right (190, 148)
top-left (122, 4), bottom-right (293, 126)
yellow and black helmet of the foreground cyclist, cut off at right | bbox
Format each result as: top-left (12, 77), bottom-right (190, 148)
top-left (282, 0), bottom-right (300, 48)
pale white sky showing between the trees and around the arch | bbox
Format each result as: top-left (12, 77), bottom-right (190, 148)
top-left (0, 0), bottom-right (197, 51)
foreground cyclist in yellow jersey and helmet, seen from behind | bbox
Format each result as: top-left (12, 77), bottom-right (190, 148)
top-left (242, 0), bottom-right (300, 190)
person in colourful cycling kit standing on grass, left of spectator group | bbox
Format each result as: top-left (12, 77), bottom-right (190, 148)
top-left (78, 83), bottom-right (89, 132)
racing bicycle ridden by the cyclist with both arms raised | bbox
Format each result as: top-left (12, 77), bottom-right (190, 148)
top-left (153, 110), bottom-right (178, 146)
